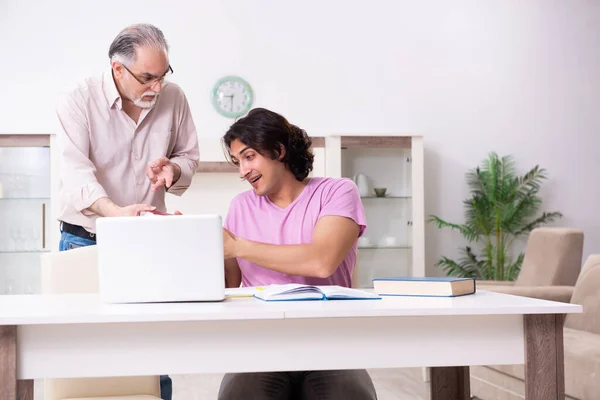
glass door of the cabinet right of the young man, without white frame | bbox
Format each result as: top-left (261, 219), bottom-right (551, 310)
top-left (341, 137), bottom-right (413, 287)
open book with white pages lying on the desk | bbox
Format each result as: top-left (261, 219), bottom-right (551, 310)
top-left (254, 283), bottom-right (381, 301)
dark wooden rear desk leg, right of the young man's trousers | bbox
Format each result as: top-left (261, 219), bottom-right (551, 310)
top-left (430, 367), bottom-right (471, 400)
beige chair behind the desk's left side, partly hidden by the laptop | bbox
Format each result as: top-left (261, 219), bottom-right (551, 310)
top-left (41, 246), bottom-right (160, 400)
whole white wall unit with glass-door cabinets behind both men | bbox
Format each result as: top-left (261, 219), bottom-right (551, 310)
top-left (0, 134), bottom-right (425, 294)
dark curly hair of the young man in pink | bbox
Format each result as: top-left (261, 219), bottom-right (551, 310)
top-left (222, 108), bottom-right (314, 181)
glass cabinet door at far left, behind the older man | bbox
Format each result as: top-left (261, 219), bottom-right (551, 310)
top-left (0, 140), bottom-right (50, 294)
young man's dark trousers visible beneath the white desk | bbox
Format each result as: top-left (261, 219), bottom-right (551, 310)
top-left (219, 370), bottom-right (377, 400)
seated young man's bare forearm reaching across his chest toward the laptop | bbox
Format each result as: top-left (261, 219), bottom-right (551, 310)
top-left (236, 238), bottom-right (330, 278)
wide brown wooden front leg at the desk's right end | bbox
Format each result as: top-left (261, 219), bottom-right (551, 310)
top-left (524, 314), bottom-right (565, 400)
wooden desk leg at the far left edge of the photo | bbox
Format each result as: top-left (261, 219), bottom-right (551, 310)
top-left (0, 326), bottom-right (17, 399)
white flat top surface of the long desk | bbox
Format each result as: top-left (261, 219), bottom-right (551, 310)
top-left (0, 290), bottom-right (582, 325)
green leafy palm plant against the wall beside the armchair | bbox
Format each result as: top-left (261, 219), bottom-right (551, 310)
top-left (428, 152), bottom-right (562, 281)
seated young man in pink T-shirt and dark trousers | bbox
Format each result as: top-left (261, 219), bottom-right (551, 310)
top-left (219, 109), bottom-right (376, 400)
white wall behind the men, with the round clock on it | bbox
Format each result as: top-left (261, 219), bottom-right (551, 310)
top-left (0, 0), bottom-right (600, 274)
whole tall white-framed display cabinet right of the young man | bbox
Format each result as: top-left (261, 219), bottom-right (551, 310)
top-left (325, 135), bottom-right (425, 287)
